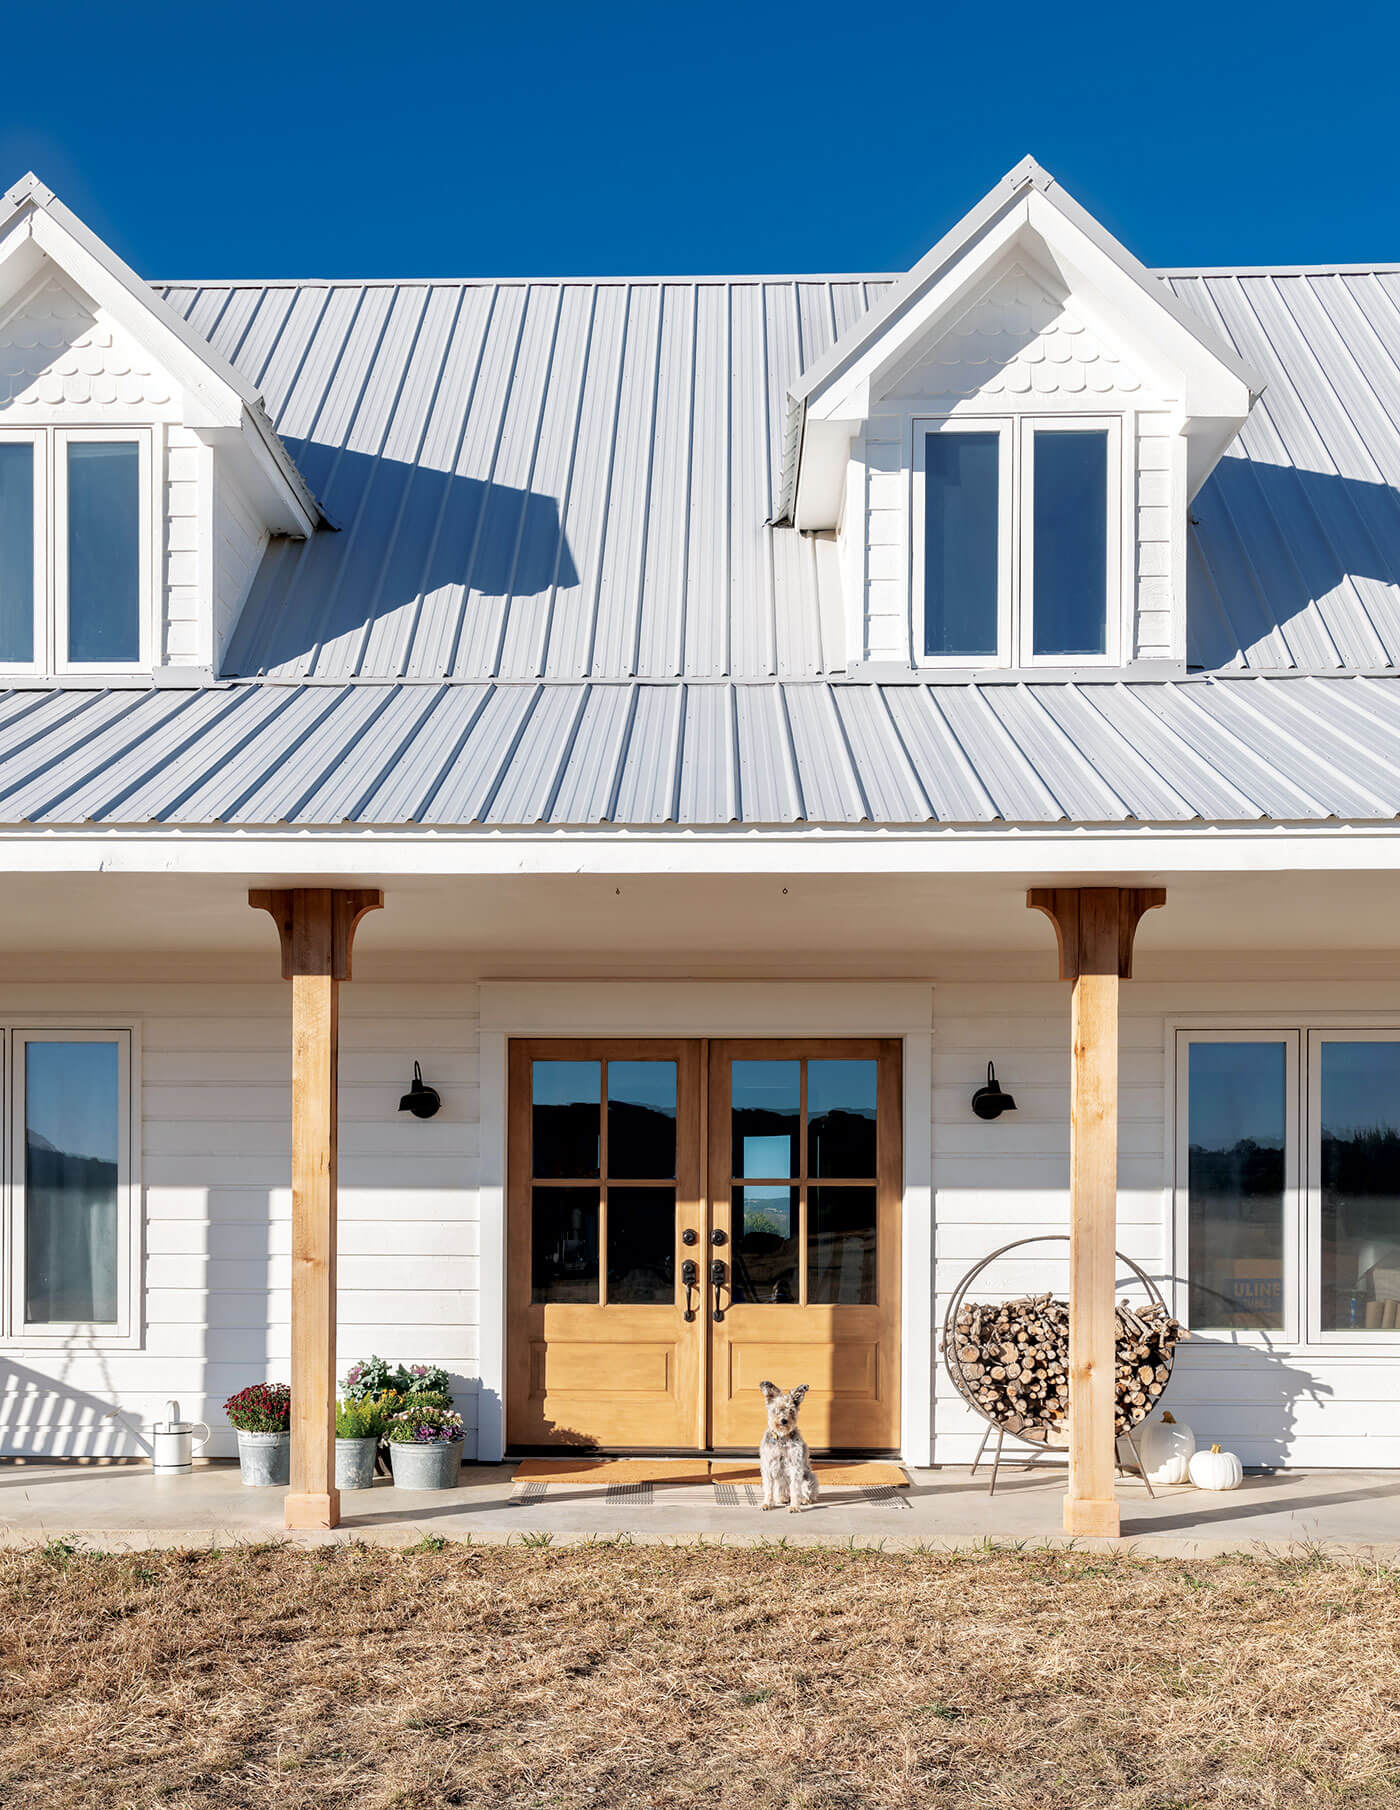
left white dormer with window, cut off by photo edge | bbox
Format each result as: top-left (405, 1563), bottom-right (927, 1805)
top-left (0, 176), bottom-right (321, 684)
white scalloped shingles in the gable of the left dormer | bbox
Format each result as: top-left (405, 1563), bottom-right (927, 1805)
top-left (0, 282), bottom-right (172, 407)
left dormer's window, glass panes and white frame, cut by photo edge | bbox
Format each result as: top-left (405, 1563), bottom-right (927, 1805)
top-left (0, 427), bottom-right (152, 673)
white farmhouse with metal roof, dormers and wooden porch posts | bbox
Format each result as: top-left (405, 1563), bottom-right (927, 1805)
top-left (0, 159), bottom-right (1400, 1531)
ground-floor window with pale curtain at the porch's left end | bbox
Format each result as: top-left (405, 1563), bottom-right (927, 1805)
top-left (0, 1028), bottom-right (139, 1347)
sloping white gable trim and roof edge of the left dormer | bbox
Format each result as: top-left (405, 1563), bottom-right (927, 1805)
top-left (0, 170), bottom-right (324, 536)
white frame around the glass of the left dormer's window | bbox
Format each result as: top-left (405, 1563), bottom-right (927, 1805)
top-left (0, 424), bottom-right (161, 677)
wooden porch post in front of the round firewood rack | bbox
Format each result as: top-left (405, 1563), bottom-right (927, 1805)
top-left (1025, 887), bottom-right (1166, 1535)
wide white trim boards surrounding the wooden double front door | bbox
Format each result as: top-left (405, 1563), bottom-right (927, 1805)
top-left (476, 981), bottom-right (935, 1464)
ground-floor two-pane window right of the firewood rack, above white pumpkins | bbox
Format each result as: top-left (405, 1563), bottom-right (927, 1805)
top-left (1175, 1026), bottom-right (1400, 1345)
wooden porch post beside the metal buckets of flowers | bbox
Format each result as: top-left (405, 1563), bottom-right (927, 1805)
top-left (248, 887), bottom-right (384, 1528)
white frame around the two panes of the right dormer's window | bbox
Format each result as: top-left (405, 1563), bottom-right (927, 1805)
top-left (907, 409), bottom-right (1137, 672)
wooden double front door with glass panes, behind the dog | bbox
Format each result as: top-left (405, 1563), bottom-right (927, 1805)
top-left (505, 1039), bottom-right (902, 1452)
